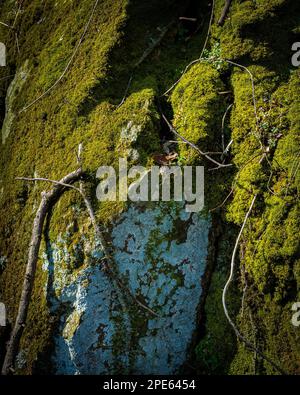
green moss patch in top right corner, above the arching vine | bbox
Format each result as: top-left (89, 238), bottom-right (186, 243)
top-left (213, 0), bottom-right (299, 72)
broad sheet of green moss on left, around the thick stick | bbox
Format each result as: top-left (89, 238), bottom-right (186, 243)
top-left (0, 0), bottom-right (217, 373)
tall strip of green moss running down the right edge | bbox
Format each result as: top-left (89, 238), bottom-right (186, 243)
top-left (198, 0), bottom-right (300, 374)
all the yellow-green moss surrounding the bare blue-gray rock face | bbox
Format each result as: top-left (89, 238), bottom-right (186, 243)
top-left (0, 0), bottom-right (300, 374)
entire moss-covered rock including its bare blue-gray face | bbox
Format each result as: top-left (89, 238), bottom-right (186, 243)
top-left (0, 0), bottom-right (300, 374)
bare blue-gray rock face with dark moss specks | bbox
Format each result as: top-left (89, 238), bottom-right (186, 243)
top-left (44, 203), bottom-right (211, 374)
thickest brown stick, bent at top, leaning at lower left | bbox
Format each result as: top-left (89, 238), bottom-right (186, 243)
top-left (2, 169), bottom-right (83, 375)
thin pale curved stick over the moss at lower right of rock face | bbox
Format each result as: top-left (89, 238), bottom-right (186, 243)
top-left (222, 194), bottom-right (287, 375)
